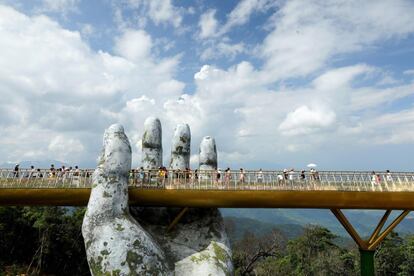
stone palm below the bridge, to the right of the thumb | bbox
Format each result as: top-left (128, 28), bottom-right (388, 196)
top-left (131, 208), bottom-right (233, 276)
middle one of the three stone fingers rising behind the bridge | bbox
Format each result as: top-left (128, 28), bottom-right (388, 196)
top-left (170, 124), bottom-right (191, 170)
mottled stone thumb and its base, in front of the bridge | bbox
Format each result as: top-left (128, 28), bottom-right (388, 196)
top-left (82, 125), bottom-right (170, 275)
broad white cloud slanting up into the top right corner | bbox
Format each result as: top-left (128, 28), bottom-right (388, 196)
top-left (258, 0), bottom-right (414, 80)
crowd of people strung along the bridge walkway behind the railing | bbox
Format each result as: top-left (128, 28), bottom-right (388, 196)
top-left (8, 164), bottom-right (393, 189)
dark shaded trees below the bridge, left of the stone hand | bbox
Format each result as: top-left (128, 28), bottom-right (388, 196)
top-left (0, 207), bottom-right (89, 275)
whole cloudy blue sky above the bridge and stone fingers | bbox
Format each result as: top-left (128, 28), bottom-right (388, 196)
top-left (0, 0), bottom-right (414, 170)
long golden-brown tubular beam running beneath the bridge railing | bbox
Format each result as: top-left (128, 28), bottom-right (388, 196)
top-left (0, 188), bottom-right (414, 210)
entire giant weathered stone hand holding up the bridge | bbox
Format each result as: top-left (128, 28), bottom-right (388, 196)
top-left (83, 118), bottom-right (233, 275)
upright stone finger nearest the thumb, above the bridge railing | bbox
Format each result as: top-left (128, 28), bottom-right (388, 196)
top-left (142, 117), bottom-right (162, 170)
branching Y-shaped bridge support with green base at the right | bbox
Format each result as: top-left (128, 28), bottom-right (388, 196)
top-left (331, 209), bottom-right (410, 276)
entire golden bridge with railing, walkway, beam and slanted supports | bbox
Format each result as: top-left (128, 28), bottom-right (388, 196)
top-left (0, 169), bottom-right (414, 275)
